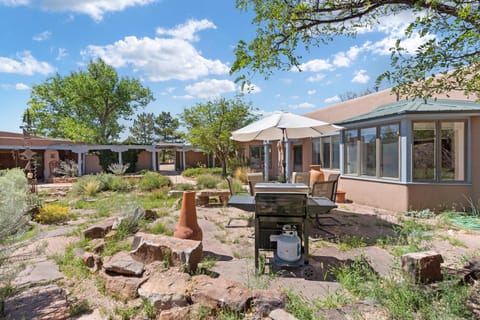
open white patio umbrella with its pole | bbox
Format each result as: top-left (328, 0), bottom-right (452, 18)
top-left (231, 111), bottom-right (342, 180)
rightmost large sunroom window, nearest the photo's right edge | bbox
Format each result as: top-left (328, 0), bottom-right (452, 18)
top-left (412, 121), bottom-right (465, 181)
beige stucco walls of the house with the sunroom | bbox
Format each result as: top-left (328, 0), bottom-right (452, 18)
top-left (240, 90), bottom-right (480, 211)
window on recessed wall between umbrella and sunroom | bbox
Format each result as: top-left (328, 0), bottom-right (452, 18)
top-left (312, 135), bottom-right (340, 169)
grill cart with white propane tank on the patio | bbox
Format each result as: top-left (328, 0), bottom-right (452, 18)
top-left (251, 183), bottom-right (315, 279)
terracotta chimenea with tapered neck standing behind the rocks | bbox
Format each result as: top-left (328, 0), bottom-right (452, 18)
top-left (173, 191), bottom-right (203, 241)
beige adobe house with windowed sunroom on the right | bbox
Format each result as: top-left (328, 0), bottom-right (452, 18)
top-left (238, 90), bottom-right (480, 211)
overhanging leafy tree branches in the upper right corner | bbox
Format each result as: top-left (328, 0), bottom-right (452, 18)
top-left (231, 0), bottom-right (480, 98)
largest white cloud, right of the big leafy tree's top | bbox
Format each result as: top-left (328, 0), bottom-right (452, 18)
top-left (83, 20), bottom-right (230, 81)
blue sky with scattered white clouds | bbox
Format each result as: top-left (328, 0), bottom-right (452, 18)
top-left (0, 0), bottom-right (420, 136)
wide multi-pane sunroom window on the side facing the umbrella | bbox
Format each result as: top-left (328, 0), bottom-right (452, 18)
top-left (344, 123), bottom-right (400, 179)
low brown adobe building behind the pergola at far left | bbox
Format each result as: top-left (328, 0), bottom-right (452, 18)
top-left (0, 131), bottom-right (212, 181)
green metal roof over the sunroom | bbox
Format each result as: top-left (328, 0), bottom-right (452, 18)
top-left (335, 99), bottom-right (480, 126)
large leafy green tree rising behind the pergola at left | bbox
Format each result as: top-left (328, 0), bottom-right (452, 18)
top-left (28, 59), bottom-right (153, 144)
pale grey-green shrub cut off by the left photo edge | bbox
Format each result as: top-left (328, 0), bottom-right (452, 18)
top-left (0, 169), bottom-right (35, 243)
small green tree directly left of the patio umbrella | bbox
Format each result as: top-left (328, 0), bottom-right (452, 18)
top-left (181, 98), bottom-right (255, 176)
